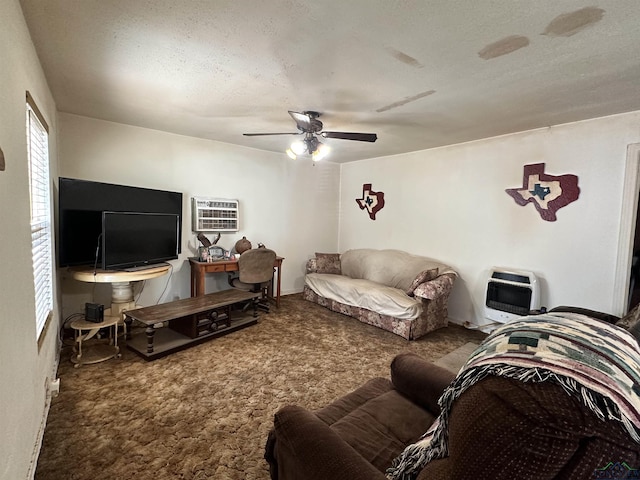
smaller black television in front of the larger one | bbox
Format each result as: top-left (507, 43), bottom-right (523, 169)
top-left (102, 212), bottom-right (180, 270)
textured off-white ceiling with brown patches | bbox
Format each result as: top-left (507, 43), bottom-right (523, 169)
top-left (20, 0), bottom-right (640, 162)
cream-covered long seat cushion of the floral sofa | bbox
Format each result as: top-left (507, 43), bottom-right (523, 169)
top-left (305, 273), bottom-right (422, 320)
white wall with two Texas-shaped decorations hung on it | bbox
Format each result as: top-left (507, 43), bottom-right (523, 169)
top-left (339, 112), bottom-right (640, 324)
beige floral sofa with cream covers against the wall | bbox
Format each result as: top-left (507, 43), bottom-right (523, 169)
top-left (303, 248), bottom-right (457, 340)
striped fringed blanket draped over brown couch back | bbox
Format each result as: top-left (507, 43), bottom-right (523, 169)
top-left (387, 313), bottom-right (640, 480)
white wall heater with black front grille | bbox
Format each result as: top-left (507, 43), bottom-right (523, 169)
top-left (484, 267), bottom-right (540, 323)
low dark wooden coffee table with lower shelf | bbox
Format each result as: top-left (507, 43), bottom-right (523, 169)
top-left (124, 288), bottom-right (261, 360)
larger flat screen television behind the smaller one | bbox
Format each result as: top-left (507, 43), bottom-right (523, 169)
top-left (56, 177), bottom-right (182, 267)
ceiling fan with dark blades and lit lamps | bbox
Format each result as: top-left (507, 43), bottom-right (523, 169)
top-left (244, 110), bottom-right (378, 160)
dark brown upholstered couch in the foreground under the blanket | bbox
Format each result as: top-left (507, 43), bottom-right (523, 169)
top-left (265, 353), bottom-right (640, 480)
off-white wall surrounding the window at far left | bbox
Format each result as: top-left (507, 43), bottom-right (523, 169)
top-left (0, 0), bottom-right (59, 480)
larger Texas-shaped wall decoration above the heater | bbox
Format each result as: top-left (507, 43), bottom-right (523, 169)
top-left (505, 163), bottom-right (580, 222)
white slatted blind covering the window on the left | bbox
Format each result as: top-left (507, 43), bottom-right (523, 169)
top-left (27, 93), bottom-right (53, 339)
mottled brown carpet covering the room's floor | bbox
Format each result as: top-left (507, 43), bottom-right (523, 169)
top-left (35, 295), bottom-right (485, 480)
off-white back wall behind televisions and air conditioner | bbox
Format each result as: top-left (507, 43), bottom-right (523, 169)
top-left (59, 113), bottom-right (340, 318)
